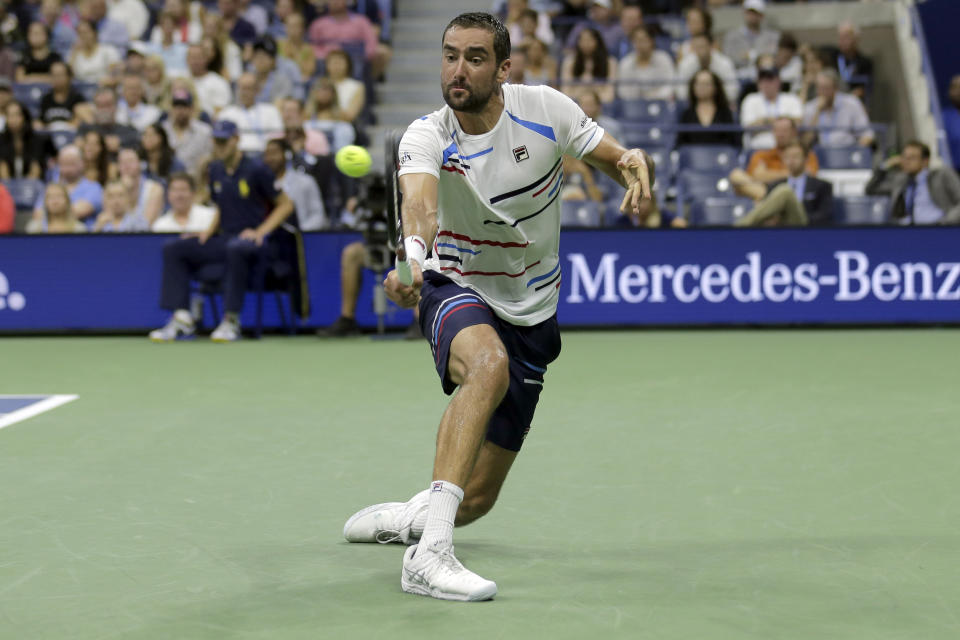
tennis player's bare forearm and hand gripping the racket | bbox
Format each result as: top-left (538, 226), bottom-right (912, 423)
top-left (383, 173), bottom-right (440, 307)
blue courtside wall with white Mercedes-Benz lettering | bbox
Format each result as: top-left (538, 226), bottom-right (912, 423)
top-left (0, 227), bottom-right (960, 332)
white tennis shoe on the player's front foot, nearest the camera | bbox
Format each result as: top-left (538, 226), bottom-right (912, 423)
top-left (400, 545), bottom-right (497, 602)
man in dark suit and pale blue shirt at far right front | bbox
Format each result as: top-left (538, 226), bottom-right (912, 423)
top-left (866, 140), bottom-right (960, 225)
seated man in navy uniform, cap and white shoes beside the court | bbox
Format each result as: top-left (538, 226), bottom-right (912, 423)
top-left (150, 120), bottom-right (293, 342)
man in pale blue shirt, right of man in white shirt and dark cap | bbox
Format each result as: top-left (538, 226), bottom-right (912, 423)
top-left (803, 69), bottom-right (874, 147)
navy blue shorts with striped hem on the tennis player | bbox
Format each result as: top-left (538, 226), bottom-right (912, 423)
top-left (420, 271), bottom-right (560, 451)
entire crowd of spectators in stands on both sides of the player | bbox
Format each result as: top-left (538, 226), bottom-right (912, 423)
top-left (0, 0), bottom-right (960, 238)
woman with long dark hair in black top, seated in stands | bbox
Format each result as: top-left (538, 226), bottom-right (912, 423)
top-left (677, 70), bottom-right (740, 147)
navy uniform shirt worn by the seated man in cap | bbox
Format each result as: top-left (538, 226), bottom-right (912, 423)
top-left (209, 157), bottom-right (277, 235)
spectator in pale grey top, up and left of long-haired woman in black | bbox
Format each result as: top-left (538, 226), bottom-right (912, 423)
top-left (617, 27), bottom-right (677, 100)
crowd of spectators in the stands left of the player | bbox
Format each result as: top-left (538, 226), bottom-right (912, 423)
top-left (0, 0), bottom-right (391, 233)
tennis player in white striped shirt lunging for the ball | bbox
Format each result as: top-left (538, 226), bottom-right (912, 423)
top-left (343, 13), bottom-right (653, 601)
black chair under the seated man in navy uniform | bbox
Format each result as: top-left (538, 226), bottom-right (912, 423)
top-left (196, 224), bottom-right (310, 339)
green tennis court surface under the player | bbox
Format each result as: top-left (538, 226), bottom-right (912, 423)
top-left (0, 329), bottom-right (960, 640)
